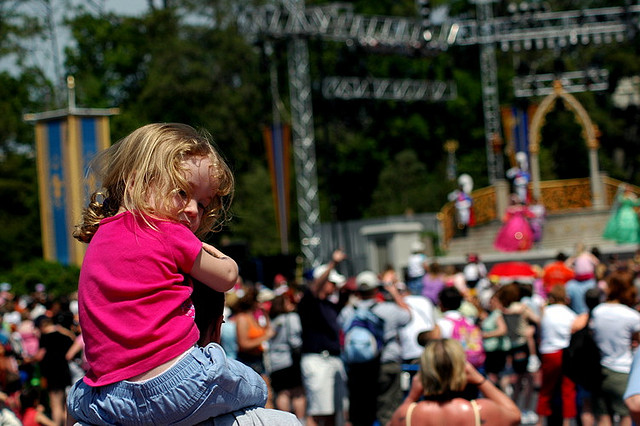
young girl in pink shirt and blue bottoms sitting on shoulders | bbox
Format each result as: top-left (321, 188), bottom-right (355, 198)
top-left (67, 124), bottom-right (267, 425)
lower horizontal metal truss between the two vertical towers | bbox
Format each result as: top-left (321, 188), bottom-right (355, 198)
top-left (322, 77), bottom-right (457, 102)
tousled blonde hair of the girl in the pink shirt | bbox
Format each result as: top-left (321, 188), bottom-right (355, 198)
top-left (73, 123), bottom-right (234, 243)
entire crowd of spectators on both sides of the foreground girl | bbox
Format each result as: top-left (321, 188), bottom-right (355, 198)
top-left (0, 244), bottom-right (640, 426)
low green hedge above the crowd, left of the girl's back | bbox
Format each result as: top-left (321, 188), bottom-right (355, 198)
top-left (0, 259), bottom-right (80, 297)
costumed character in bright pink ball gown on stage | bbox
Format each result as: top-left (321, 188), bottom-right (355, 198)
top-left (493, 194), bottom-right (534, 251)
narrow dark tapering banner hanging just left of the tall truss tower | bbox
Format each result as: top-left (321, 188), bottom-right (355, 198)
top-left (263, 124), bottom-right (291, 253)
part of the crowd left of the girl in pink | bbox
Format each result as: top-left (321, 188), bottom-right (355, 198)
top-left (0, 283), bottom-right (86, 426)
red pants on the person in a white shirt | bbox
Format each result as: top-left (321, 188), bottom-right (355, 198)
top-left (536, 351), bottom-right (578, 419)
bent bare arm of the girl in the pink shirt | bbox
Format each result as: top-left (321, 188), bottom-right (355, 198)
top-left (191, 243), bottom-right (238, 292)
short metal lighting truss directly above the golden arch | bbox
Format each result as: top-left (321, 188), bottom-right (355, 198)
top-left (513, 69), bottom-right (609, 98)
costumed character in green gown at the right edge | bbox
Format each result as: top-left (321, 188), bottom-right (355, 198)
top-left (602, 183), bottom-right (640, 244)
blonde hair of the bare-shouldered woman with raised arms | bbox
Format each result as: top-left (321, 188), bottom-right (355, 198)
top-left (420, 339), bottom-right (467, 397)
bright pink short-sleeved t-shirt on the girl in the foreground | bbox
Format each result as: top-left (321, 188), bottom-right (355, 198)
top-left (78, 212), bottom-right (202, 386)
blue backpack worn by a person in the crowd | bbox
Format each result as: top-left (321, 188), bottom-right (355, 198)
top-left (343, 306), bottom-right (384, 364)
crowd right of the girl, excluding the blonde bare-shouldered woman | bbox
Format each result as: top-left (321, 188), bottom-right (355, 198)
top-left (170, 244), bottom-right (640, 425)
